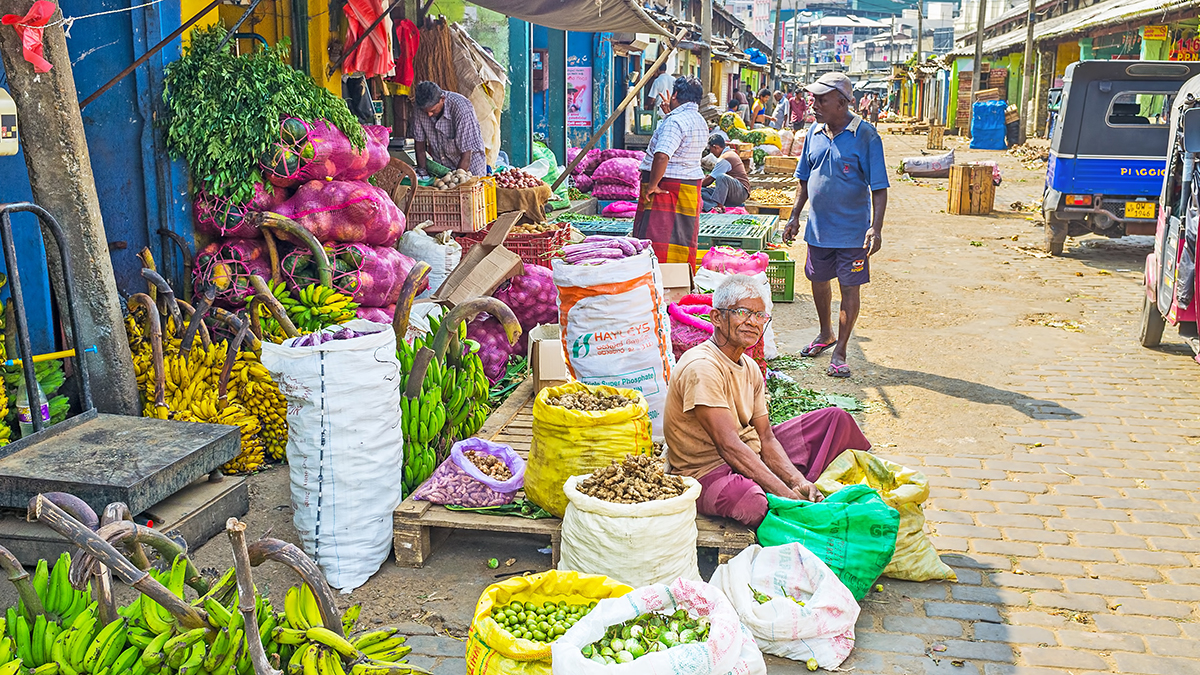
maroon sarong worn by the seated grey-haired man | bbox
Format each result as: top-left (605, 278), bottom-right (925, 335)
top-left (696, 408), bottom-right (871, 530)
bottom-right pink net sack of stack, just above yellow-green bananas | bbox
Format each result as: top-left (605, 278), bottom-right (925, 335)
top-left (280, 244), bottom-right (424, 307)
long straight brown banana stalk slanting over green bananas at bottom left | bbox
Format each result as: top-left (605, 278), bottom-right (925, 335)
top-left (25, 495), bottom-right (209, 628)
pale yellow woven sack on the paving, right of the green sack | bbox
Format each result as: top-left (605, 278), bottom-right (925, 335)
top-left (817, 450), bottom-right (959, 581)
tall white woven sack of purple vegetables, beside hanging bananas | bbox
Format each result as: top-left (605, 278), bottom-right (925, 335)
top-left (263, 319), bottom-right (403, 593)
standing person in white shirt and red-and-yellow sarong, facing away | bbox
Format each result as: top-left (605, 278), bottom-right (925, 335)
top-left (634, 77), bottom-right (708, 261)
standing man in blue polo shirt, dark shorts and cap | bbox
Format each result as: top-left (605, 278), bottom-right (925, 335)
top-left (784, 72), bottom-right (888, 377)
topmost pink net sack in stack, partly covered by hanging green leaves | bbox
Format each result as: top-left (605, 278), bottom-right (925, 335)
top-left (258, 118), bottom-right (391, 187)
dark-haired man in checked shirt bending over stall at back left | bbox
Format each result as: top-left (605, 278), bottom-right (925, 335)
top-left (410, 82), bottom-right (487, 175)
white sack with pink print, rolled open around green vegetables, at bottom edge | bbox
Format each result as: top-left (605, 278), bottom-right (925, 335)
top-left (550, 571), bottom-right (767, 675)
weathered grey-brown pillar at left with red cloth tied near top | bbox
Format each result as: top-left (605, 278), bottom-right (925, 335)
top-left (0, 0), bottom-right (140, 414)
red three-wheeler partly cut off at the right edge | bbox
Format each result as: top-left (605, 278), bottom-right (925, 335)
top-left (1140, 72), bottom-right (1200, 353)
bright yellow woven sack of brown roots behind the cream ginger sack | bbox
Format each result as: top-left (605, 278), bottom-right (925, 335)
top-left (524, 382), bottom-right (654, 518)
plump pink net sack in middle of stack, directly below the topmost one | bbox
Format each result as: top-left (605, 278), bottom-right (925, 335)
top-left (272, 180), bottom-right (404, 246)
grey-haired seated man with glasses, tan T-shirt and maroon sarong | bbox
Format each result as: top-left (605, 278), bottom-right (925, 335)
top-left (662, 275), bottom-right (871, 528)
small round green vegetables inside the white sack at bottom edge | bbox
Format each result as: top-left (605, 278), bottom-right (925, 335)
top-left (580, 609), bottom-right (708, 665)
